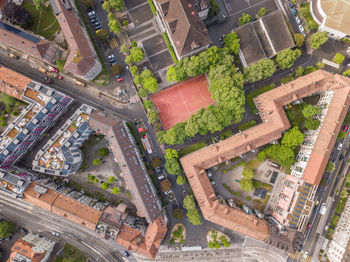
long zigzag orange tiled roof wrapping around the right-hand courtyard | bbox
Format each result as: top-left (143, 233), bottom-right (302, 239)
top-left (181, 70), bottom-right (350, 240)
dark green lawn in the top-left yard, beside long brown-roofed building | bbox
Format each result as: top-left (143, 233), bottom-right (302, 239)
top-left (23, 2), bottom-right (60, 40)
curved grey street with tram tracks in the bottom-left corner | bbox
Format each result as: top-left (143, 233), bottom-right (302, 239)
top-left (0, 195), bottom-right (129, 262)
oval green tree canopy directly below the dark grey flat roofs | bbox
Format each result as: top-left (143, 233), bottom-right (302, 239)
top-left (244, 59), bottom-right (276, 83)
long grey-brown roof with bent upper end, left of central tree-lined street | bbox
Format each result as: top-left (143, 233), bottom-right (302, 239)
top-left (89, 111), bottom-right (161, 223)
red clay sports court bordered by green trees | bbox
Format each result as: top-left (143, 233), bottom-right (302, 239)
top-left (152, 75), bottom-right (215, 130)
